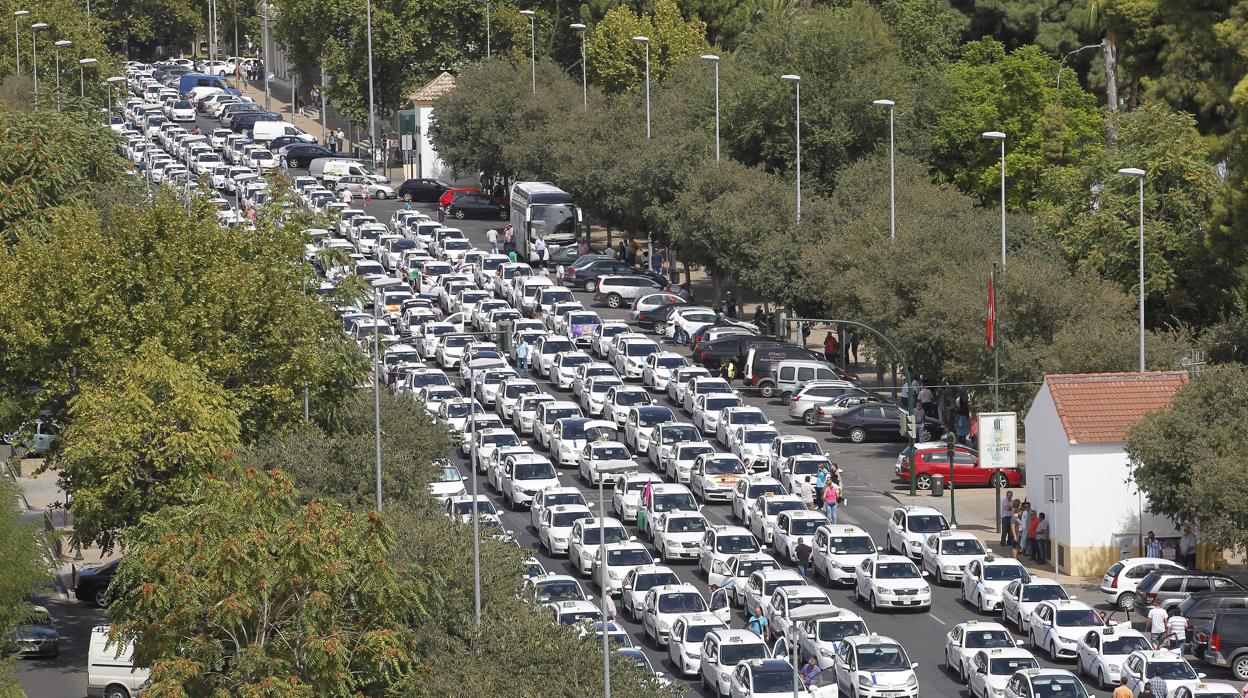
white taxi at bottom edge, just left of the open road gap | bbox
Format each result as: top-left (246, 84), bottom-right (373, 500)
top-left (832, 634), bottom-right (919, 698)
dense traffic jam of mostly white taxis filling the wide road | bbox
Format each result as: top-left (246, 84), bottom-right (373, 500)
top-left (58, 57), bottom-right (1248, 698)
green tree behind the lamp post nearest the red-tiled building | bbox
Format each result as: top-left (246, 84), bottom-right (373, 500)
top-left (1040, 105), bottom-right (1232, 326)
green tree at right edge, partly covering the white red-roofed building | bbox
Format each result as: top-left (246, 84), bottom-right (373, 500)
top-left (1127, 363), bottom-right (1248, 551)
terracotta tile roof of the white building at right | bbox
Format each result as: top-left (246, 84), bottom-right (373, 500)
top-left (1045, 371), bottom-right (1188, 443)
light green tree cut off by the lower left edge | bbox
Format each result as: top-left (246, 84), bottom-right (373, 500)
top-left (0, 481), bottom-right (52, 696)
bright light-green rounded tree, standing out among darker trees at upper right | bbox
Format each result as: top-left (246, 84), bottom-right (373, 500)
top-left (930, 40), bottom-right (1103, 209)
